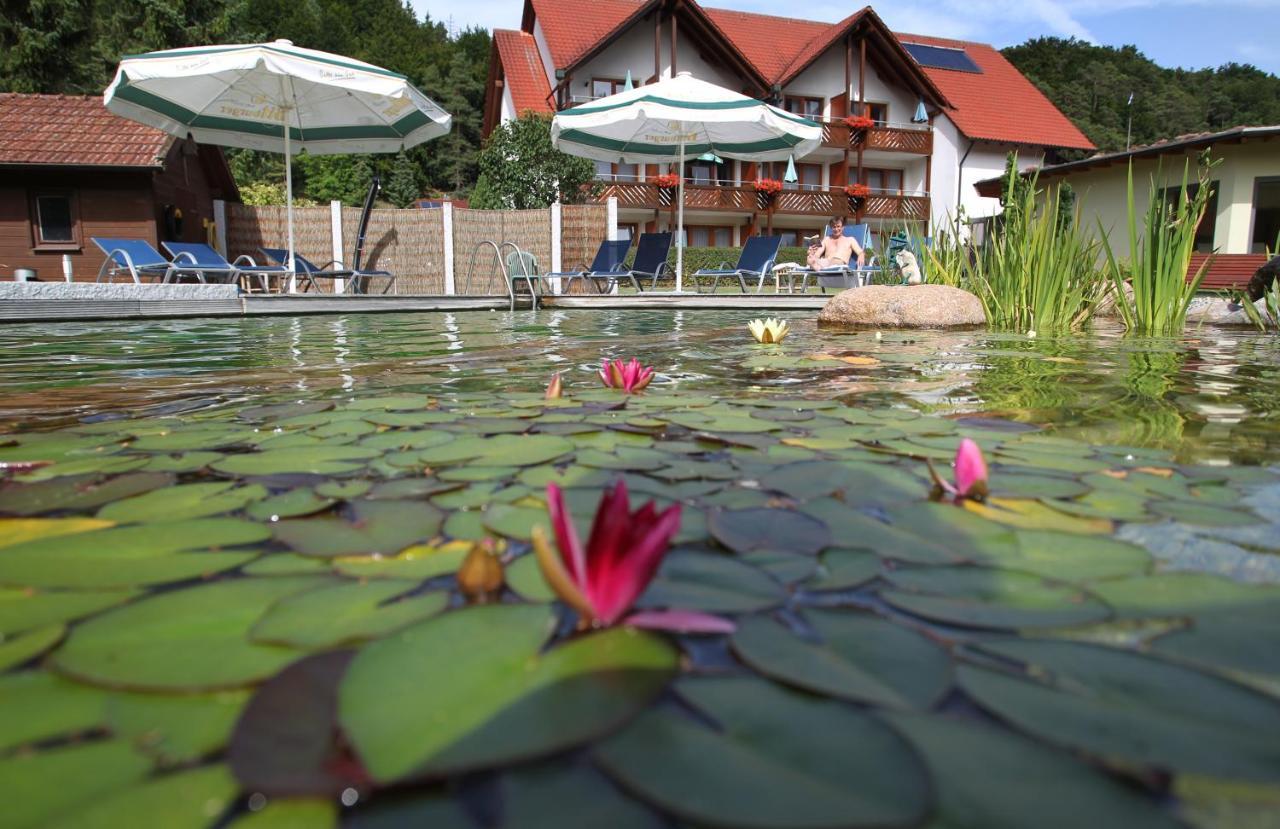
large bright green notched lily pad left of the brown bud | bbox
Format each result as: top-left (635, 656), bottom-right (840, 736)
top-left (52, 576), bottom-right (328, 691)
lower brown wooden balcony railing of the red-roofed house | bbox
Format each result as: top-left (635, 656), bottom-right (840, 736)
top-left (588, 179), bottom-right (929, 220)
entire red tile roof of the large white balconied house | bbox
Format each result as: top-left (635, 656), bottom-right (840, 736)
top-left (503, 0), bottom-right (1093, 150)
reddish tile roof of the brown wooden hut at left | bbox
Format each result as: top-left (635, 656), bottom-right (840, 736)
top-left (0, 92), bottom-right (173, 168)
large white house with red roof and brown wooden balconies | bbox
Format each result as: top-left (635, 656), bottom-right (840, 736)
top-left (485, 0), bottom-right (1093, 247)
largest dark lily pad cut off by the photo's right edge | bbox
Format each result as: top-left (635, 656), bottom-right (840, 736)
top-left (959, 640), bottom-right (1280, 780)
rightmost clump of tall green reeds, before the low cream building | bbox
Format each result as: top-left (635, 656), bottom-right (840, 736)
top-left (1098, 157), bottom-right (1212, 334)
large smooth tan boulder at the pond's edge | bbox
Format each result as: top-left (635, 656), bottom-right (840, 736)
top-left (818, 285), bottom-right (987, 328)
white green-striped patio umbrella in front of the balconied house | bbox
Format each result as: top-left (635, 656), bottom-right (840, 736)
top-left (552, 72), bottom-right (822, 292)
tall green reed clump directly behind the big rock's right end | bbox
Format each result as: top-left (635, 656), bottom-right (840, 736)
top-left (929, 165), bottom-right (1111, 331)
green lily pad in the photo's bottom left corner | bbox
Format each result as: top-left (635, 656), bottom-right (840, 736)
top-left (0, 739), bottom-right (151, 829)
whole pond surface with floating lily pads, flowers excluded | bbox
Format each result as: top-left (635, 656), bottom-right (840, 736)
top-left (0, 311), bottom-right (1280, 828)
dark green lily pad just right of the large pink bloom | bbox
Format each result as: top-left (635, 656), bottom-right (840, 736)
top-left (637, 553), bottom-right (786, 613)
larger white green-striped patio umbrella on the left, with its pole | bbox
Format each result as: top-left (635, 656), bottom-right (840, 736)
top-left (104, 40), bottom-right (452, 290)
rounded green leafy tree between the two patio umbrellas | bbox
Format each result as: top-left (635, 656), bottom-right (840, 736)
top-left (471, 113), bottom-right (595, 210)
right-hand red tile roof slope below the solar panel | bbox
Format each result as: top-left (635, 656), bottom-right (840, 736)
top-left (897, 35), bottom-right (1093, 150)
